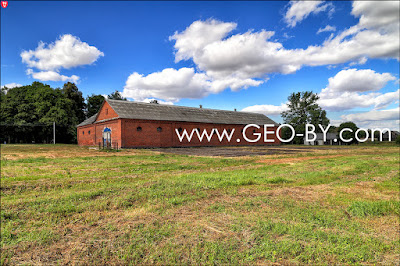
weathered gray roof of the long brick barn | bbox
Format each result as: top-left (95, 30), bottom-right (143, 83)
top-left (78, 99), bottom-right (278, 126)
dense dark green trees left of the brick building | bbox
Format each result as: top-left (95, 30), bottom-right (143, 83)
top-left (0, 81), bottom-right (126, 143)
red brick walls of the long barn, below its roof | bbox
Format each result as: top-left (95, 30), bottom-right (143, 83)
top-left (78, 119), bottom-right (280, 148)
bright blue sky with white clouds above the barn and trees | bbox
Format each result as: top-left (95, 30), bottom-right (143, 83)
top-left (1, 1), bottom-right (399, 129)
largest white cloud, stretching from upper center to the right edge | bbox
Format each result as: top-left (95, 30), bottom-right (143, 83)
top-left (171, 2), bottom-right (400, 83)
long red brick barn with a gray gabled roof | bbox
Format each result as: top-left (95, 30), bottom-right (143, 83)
top-left (77, 100), bottom-right (280, 148)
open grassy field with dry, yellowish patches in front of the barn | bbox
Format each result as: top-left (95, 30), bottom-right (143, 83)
top-left (1, 144), bottom-right (400, 264)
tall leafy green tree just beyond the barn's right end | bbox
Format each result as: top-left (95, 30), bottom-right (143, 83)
top-left (281, 91), bottom-right (329, 144)
